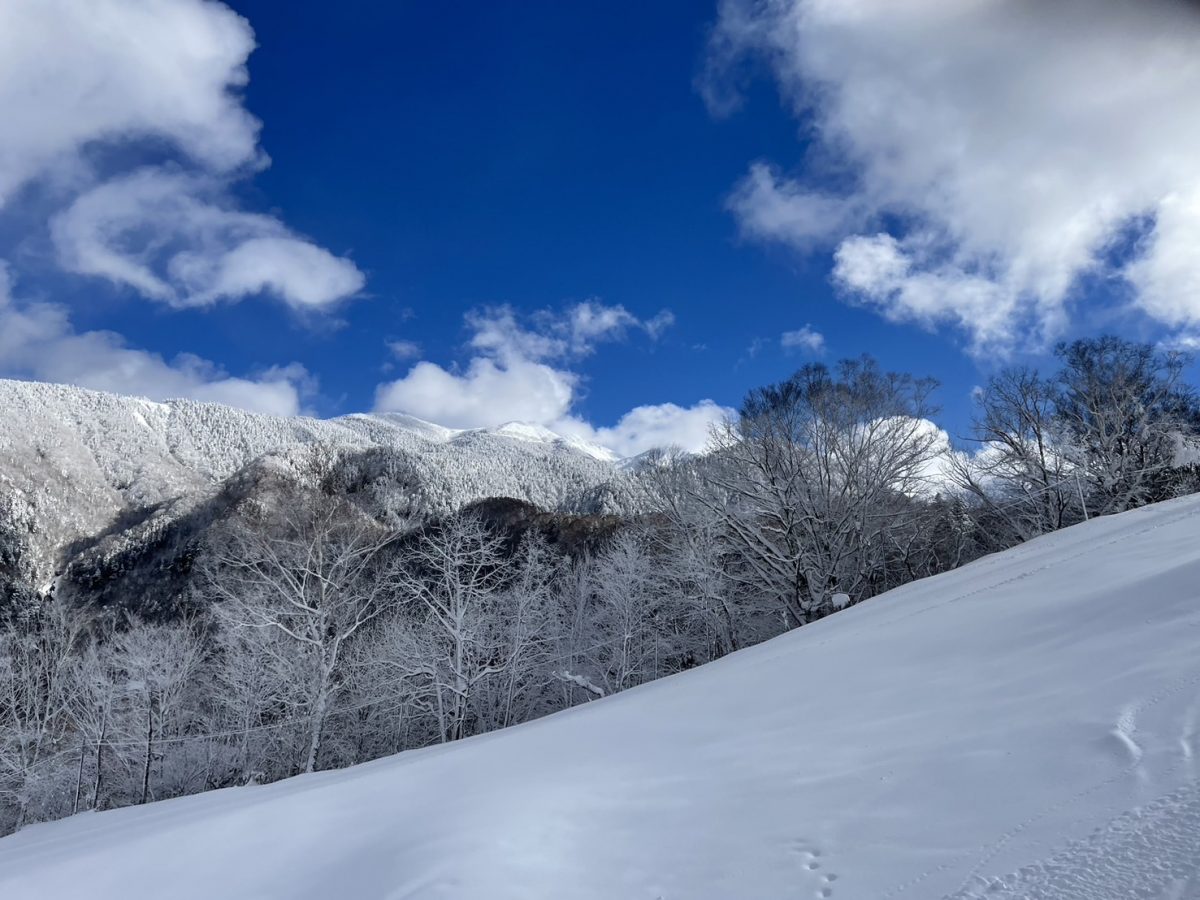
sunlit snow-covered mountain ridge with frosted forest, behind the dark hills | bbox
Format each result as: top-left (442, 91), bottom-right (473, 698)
top-left (0, 380), bottom-right (642, 592)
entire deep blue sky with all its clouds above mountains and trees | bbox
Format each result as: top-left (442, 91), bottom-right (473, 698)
top-left (0, 0), bottom-right (1200, 451)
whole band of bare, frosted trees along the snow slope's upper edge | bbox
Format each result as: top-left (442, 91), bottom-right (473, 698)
top-left (0, 338), bottom-right (1200, 830)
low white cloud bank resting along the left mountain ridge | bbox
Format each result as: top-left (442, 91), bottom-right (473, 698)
top-left (0, 264), bottom-right (313, 415)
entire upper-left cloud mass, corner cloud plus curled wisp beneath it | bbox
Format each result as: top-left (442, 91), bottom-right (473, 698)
top-left (0, 0), bottom-right (364, 310)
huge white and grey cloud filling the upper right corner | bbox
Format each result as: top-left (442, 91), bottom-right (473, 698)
top-left (702, 0), bottom-right (1200, 353)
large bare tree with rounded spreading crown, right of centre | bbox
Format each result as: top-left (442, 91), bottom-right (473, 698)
top-left (698, 358), bottom-right (938, 628)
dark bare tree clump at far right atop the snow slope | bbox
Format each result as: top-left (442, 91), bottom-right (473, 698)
top-left (954, 336), bottom-right (1200, 548)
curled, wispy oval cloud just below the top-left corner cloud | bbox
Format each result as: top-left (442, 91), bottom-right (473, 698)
top-left (50, 168), bottom-right (364, 310)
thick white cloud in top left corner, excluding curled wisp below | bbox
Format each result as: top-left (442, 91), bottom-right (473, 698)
top-left (0, 0), bottom-right (259, 205)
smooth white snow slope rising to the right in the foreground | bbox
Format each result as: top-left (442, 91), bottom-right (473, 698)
top-left (0, 497), bottom-right (1200, 900)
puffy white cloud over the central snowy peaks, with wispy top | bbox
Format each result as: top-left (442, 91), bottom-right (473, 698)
top-left (376, 300), bottom-right (727, 456)
